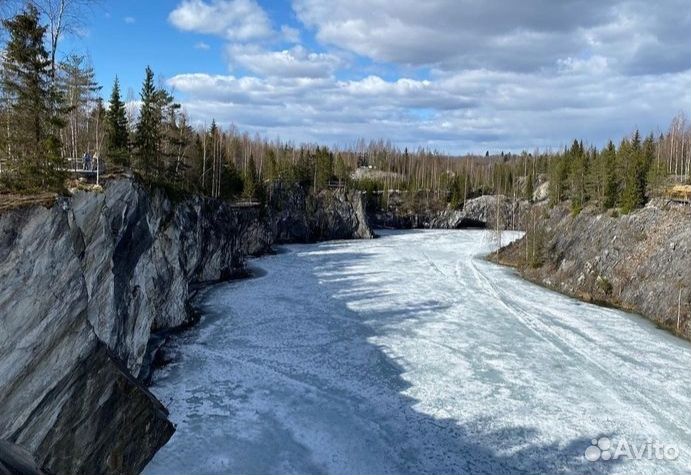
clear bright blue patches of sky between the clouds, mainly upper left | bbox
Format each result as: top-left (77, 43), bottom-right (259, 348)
top-left (62, 0), bottom-right (348, 97)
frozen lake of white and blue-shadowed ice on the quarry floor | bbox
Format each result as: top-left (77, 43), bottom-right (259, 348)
top-left (146, 231), bottom-right (691, 474)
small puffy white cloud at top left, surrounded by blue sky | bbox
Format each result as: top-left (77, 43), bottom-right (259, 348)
top-left (168, 0), bottom-right (273, 41)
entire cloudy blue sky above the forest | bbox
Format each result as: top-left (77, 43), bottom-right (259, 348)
top-left (52, 0), bottom-right (691, 154)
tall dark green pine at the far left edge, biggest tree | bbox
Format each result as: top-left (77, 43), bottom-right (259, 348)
top-left (1, 4), bottom-right (64, 189)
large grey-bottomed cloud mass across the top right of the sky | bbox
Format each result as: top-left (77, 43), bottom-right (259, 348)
top-left (293, 0), bottom-right (691, 74)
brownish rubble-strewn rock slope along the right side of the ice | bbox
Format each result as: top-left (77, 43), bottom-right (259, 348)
top-left (498, 200), bottom-right (691, 339)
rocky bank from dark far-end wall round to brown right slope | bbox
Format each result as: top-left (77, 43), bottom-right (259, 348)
top-left (369, 192), bottom-right (691, 339)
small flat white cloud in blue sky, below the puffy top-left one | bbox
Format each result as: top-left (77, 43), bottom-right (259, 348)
top-left (228, 45), bottom-right (341, 77)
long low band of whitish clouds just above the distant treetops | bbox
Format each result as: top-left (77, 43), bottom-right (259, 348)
top-left (169, 70), bottom-right (691, 153)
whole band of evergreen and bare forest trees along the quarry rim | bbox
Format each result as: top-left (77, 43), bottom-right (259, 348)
top-left (0, 0), bottom-right (691, 212)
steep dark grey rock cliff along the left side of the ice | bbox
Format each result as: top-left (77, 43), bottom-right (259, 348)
top-left (0, 179), bottom-right (371, 474)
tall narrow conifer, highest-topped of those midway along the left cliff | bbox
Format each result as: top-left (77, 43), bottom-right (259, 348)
top-left (135, 66), bottom-right (161, 178)
